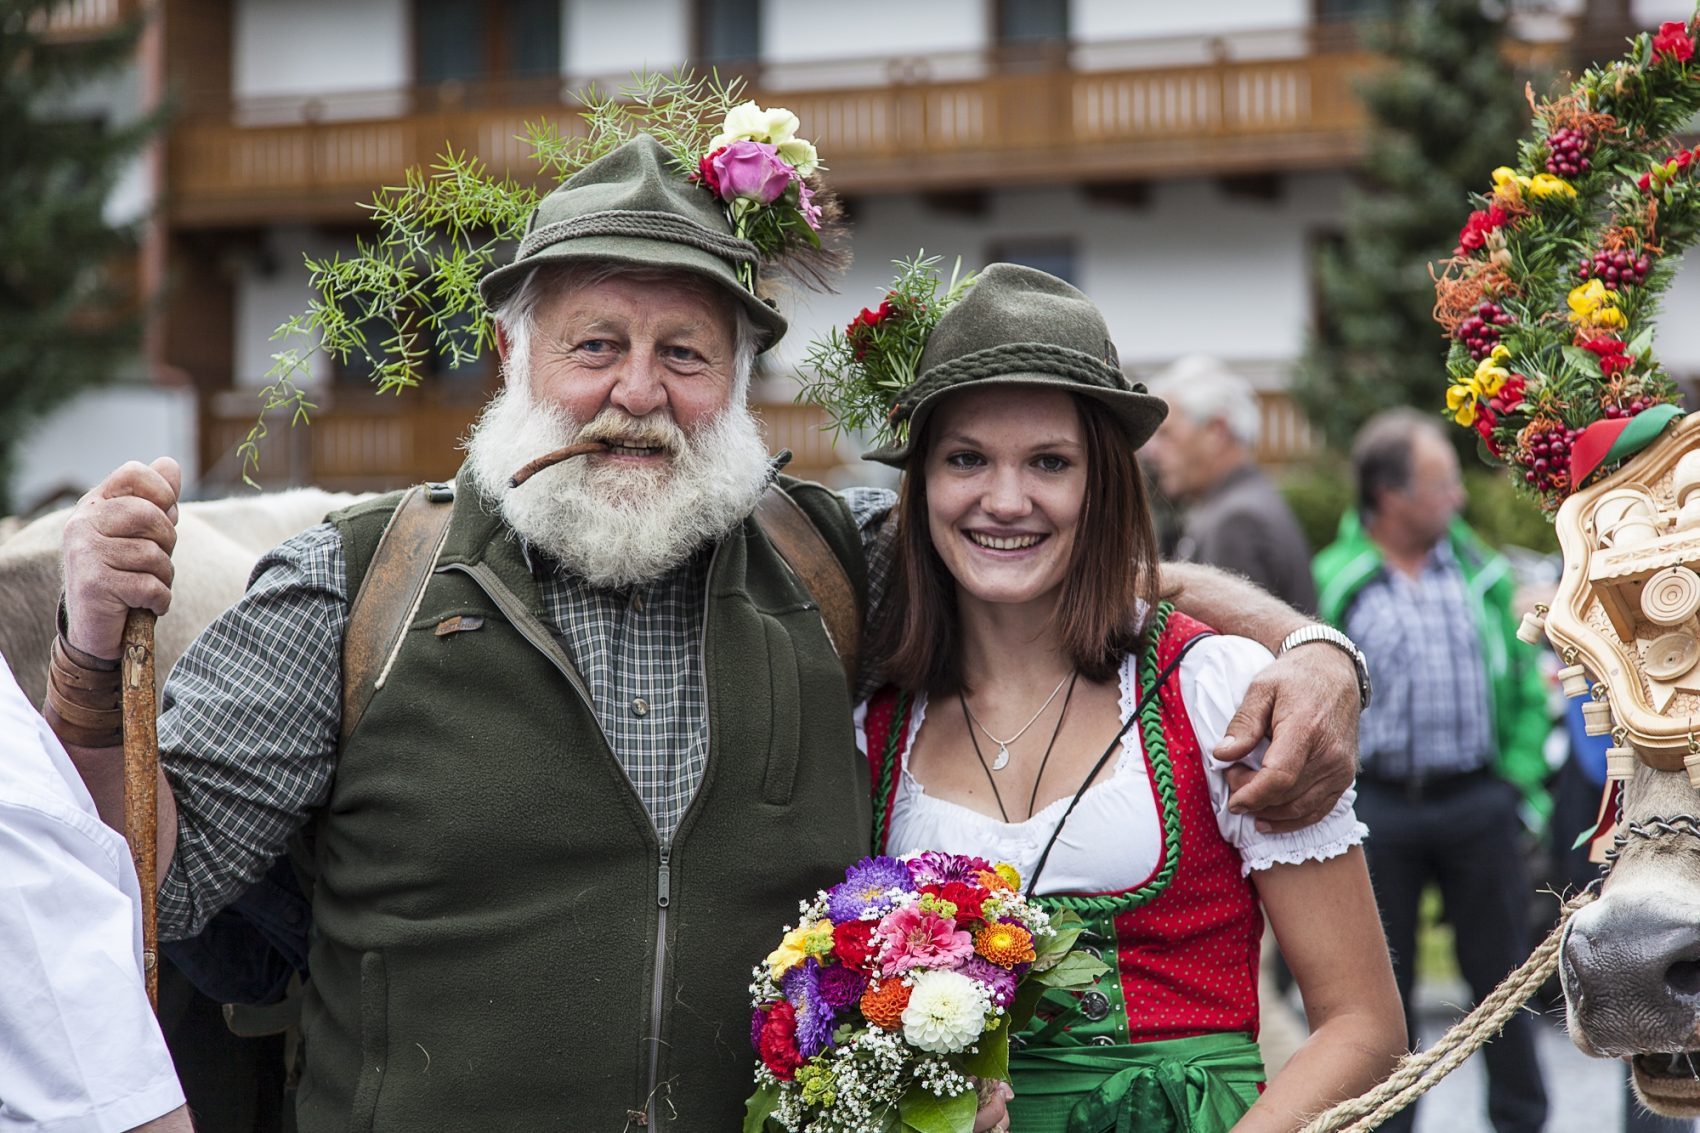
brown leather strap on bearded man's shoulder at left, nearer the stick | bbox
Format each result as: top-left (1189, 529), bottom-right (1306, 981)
top-left (342, 483), bottom-right (454, 743)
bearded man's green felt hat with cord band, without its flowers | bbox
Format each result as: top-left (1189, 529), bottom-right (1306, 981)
top-left (478, 134), bottom-right (785, 350)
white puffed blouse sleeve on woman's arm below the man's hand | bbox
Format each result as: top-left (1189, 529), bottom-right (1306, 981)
top-left (1180, 635), bottom-right (1369, 874)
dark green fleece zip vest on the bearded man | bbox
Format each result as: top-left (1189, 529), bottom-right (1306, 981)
top-left (299, 466), bottom-right (870, 1133)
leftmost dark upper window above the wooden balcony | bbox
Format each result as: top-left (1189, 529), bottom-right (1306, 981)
top-left (413, 0), bottom-right (561, 87)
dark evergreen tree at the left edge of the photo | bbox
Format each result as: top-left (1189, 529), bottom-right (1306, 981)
top-left (0, 0), bottom-right (158, 512)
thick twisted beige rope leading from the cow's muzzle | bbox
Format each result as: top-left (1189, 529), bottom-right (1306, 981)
top-left (1301, 886), bottom-right (1596, 1133)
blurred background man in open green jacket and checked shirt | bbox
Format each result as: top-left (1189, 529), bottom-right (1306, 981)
top-left (1316, 410), bottom-right (1550, 1133)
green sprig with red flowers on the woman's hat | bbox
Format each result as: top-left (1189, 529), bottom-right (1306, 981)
top-left (801, 252), bottom-right (974, 436)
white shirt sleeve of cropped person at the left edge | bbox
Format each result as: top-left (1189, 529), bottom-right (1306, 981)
top-left (0, 663), bottom-right (184, 1133)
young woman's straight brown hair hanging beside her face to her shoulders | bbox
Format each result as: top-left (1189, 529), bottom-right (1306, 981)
top-left (872, 387), bottom-right (1158, 694)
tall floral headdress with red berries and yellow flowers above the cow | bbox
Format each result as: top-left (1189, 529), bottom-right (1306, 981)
top-left (1435, 15), bottom-right (1700, 514)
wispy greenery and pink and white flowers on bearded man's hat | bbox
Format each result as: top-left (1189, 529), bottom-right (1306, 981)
top-left (240, 71), bottom-right (847, 483)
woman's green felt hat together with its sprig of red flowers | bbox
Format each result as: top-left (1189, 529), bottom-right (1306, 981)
top-left (806, 259), bottom-right (1168, 468)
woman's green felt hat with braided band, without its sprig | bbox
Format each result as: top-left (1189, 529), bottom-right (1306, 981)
top-left (865, 264), bottom-right (1168, 468)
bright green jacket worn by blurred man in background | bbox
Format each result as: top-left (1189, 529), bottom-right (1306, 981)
top-left (1311, 509), bottom-right (1552, 827)
